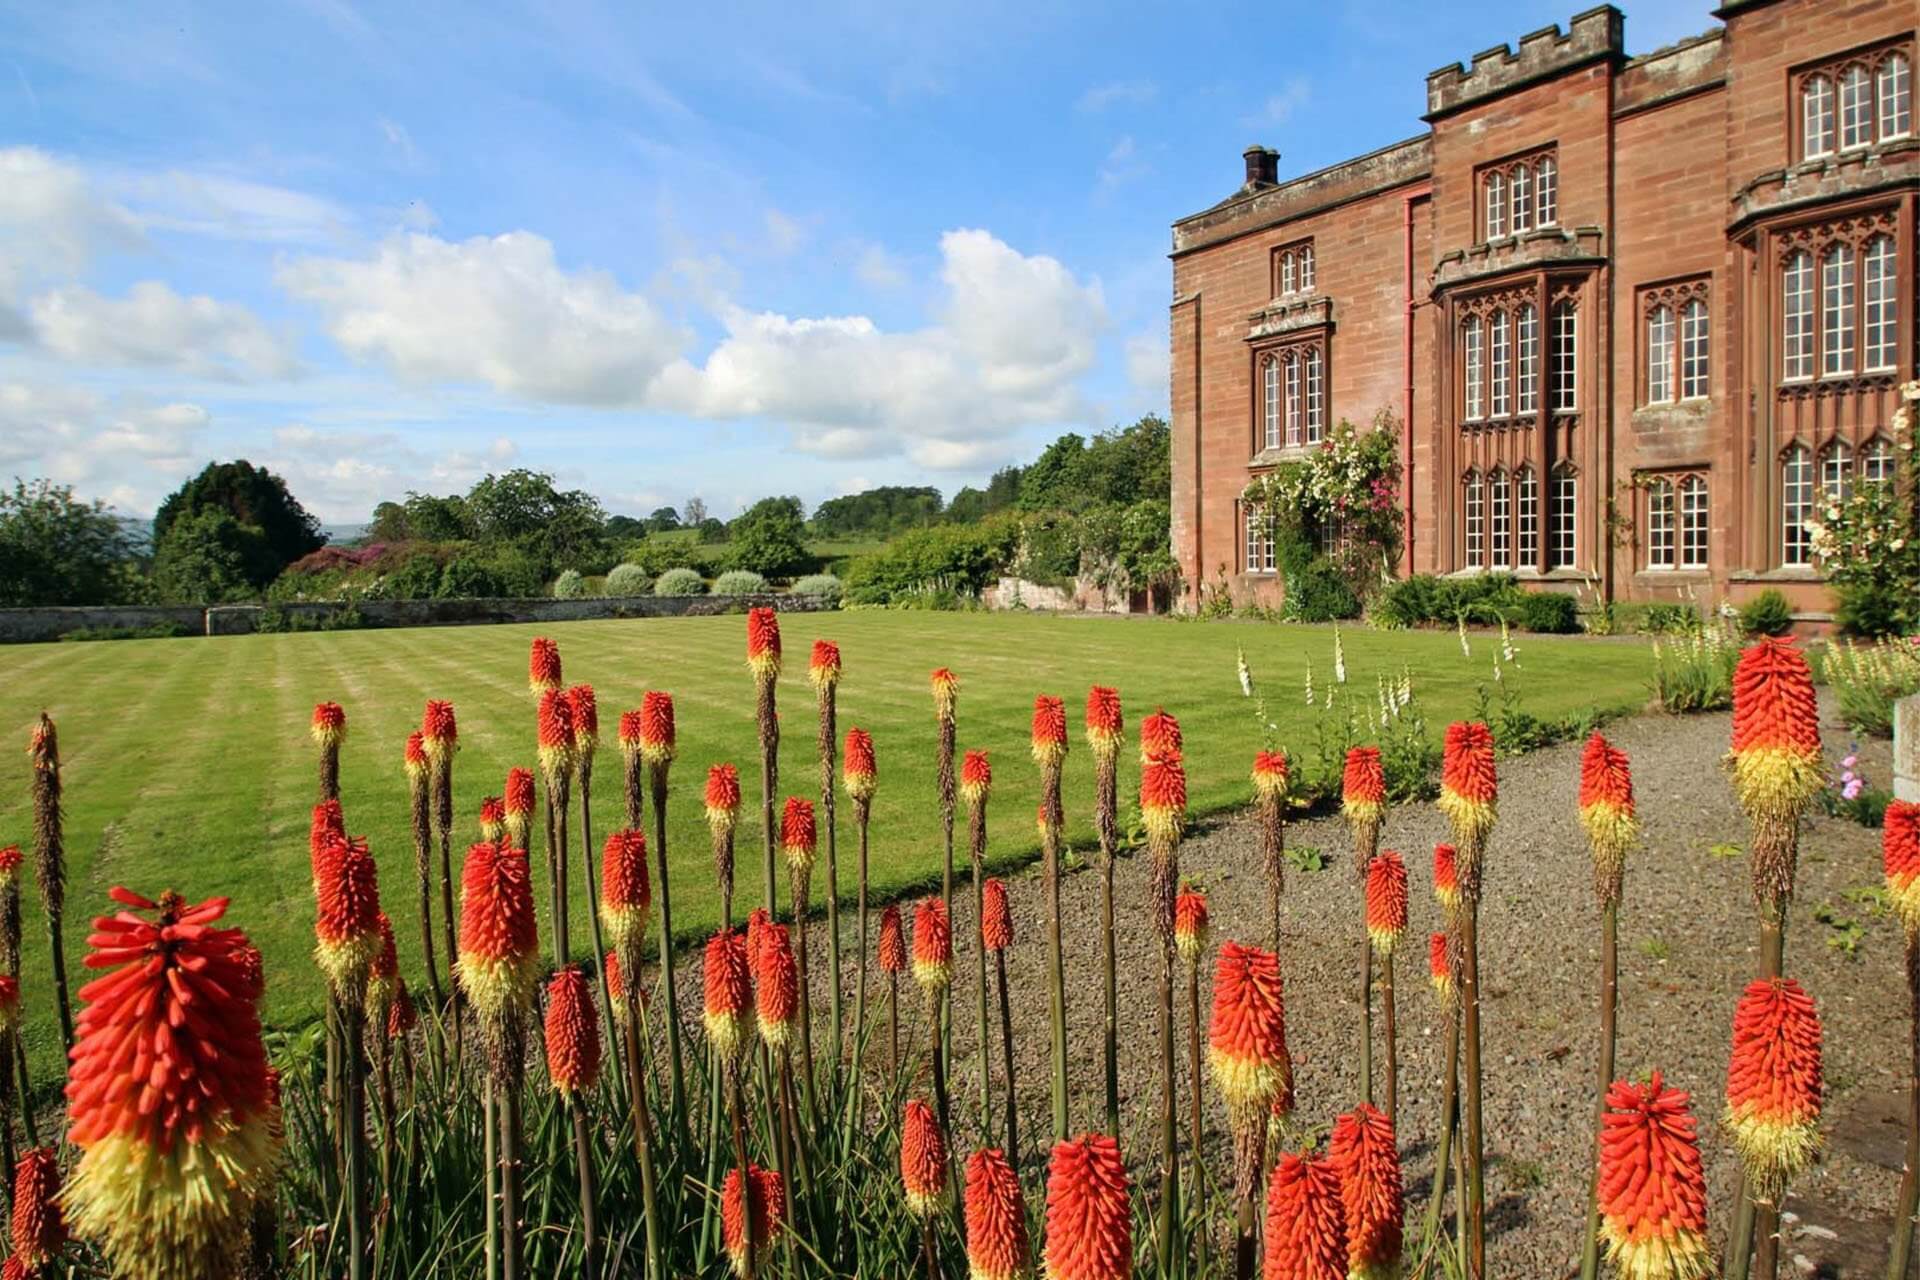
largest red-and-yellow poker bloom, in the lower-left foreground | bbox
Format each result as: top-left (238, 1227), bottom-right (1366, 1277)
top-left (63, 889), bottom-right (278, 1280)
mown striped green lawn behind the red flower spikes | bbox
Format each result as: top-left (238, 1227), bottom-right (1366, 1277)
top-left (0, 612), bottom-right (1647, 1079)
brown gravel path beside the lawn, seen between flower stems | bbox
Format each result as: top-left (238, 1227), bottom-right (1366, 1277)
top-left (684, 714), bottom-right (1908, 1276)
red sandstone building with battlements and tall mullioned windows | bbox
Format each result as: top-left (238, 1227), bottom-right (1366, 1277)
top-left (1171, 0), bottom-right (1920, 612)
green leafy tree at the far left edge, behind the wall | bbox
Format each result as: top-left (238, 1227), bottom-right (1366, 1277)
top-left (0, 478), bottom-right (134, 608)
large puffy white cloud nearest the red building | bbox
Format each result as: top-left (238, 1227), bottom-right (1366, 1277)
top-left (651, 230), bottom-right (1106, 468)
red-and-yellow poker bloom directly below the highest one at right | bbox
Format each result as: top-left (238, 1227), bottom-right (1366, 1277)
top-left (1726, 979), bottom-right (1822, 1199)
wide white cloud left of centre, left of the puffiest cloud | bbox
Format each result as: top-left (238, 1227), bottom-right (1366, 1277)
top-left (278, 230), bottom-right (685, 405)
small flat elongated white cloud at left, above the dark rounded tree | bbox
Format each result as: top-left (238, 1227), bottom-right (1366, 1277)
top-left (31, 280), bottom-right (294, 378)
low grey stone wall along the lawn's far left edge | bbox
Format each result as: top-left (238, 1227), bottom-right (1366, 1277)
top-left (0, 593), bottom-right (839, 643)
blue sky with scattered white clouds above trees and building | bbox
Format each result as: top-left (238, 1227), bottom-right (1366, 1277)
top-left (0, 0), bottom-right (1713, 522)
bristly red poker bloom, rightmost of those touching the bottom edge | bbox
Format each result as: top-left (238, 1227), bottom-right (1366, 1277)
top-left (1599, 1071), bottom-right (1713, 1280)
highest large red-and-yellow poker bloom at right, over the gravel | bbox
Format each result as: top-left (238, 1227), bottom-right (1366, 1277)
top-left (1732, 637), bottom-right (1826, 821)
